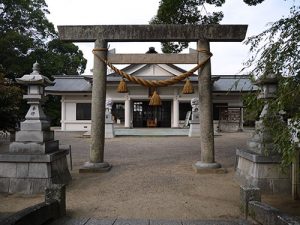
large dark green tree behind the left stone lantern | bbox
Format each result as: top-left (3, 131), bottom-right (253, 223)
top-left (0, 0), bottom-right (87, 128)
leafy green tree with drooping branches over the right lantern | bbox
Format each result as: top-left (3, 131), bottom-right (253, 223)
top-left (244, 5), bottom-right (300, 165)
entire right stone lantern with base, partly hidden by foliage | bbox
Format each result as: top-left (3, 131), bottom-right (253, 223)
top-left (235, 74), bottom-right (292, 193)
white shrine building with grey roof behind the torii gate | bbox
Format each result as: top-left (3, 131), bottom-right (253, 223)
top-left (46, 47), bottom-right (256, 131)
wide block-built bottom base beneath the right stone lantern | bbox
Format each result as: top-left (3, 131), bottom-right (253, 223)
top-left (235, 149), bottom-right (292, 194)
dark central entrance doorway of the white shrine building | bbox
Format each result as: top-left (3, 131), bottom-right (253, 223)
top-left (132, 100), bottom-right (171, 128)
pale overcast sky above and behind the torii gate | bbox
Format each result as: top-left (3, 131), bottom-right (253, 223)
top-left (46, 0), bottom-right (297, 75)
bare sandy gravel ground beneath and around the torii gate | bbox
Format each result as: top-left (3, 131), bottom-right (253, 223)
top-left (0, 132), bottom-right (300, 219)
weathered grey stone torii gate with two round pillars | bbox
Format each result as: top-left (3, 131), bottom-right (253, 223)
top-left (58, 24), bottom-right (247, 172)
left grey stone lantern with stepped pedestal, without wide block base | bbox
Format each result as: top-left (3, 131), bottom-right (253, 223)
top-left (9, 62), bottom-right (58, 153)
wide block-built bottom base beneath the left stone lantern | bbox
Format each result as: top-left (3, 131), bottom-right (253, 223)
top-left (0, 150), bottom-right (72, 194)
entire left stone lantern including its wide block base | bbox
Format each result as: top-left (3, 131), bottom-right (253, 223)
top-left (0, 63), bottom-right (71, 194)
